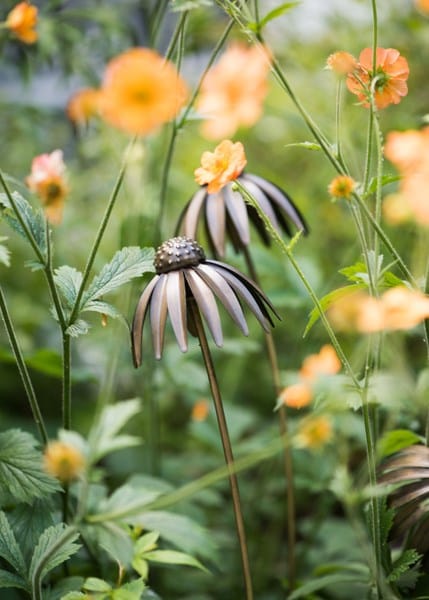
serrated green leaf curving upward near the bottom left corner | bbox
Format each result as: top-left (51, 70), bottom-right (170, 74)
top-left (29, 523), bottom-right (80, 594)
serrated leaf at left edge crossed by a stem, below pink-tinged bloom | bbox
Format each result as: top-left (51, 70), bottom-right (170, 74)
top-left (0, 192), bottom-right (47, 257)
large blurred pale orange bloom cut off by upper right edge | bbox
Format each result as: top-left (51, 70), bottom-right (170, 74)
top-left (384, 127), bottom-right (429, 226)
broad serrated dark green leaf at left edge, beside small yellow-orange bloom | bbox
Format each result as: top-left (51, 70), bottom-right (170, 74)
top-left (0, 429), bottom-right (60, 504)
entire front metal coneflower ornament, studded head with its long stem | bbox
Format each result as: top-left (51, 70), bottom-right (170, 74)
top-left (131, 237), bottom-right (278, 600)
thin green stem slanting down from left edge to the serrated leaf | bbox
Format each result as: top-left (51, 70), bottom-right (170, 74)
top-left (0, 286), bottom-right (48, 445)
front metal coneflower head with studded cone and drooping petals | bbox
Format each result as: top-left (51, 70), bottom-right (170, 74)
top-left (131, 237), bottom-right (278, 367)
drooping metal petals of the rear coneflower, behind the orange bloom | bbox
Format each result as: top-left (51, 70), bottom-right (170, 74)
top-left (177, 171), bottom-right (308, 257)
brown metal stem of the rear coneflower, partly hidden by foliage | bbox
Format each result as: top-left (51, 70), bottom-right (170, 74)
top-left (243, 246), bottom-right (296, 590)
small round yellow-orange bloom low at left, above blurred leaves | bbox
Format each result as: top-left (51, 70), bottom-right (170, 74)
top-left (43, 441), bottom-right (85, 483)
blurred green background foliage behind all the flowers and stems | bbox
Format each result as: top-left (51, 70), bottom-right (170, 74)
top-left (0, 0), bottom-right (429, 600)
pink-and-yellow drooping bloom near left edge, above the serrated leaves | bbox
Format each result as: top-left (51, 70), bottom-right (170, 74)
top-left (26, 150), bottom-right (68, 225)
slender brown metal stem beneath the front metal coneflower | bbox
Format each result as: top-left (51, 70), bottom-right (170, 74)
top-left (189, 299), bottom-right (253, 600)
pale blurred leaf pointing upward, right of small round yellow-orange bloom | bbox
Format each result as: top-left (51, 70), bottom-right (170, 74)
top-left (90, 398), bottom-right (141, 461)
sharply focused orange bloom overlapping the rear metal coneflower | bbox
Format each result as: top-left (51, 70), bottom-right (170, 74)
top-left (194, 140), bottom-right (247, 194)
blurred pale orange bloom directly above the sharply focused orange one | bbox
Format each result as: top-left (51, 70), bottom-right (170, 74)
top-left (197, 43), bottom-right (270, 140)
